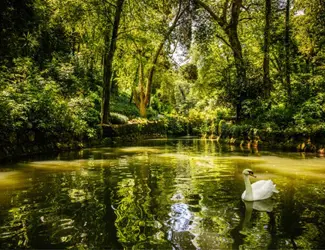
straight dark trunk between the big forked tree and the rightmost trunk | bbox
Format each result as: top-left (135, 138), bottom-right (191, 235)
top-left (263, 0), bottom-right (272, 98)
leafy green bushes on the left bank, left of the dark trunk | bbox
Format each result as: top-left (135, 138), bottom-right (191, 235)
top-left (0, 58), bottom-right (99, 148)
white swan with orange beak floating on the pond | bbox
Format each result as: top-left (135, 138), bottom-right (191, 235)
top-left (241, 169), bottom-right (279, 201)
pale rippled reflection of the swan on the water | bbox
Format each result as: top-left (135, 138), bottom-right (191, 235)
top-left (243, 198), bottom-right (274, 229)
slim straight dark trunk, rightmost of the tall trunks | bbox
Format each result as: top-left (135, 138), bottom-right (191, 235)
top-left (284, 0), bottom-right (292, 105)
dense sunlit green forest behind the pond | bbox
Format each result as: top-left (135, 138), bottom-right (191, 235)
top-left (0, 0), bottom-right (325, 153)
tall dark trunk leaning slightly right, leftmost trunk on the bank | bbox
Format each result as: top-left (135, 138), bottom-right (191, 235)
top-left (102, 0), bottom-right (124, 124)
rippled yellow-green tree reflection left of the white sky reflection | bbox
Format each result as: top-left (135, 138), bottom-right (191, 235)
top-left (115, 158), bottom-right (170, 248)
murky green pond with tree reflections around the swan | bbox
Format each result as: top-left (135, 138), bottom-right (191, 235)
top-left (0, 139), bottom-right (325, 249)
